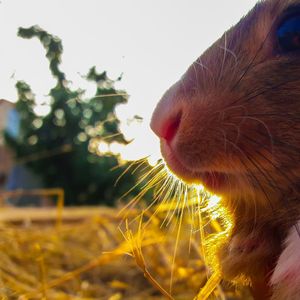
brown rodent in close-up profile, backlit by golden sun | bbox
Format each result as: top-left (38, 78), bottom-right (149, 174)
top-left (151, 0), bottom-right (300, 300)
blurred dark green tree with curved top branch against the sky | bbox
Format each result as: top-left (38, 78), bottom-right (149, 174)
top-left (5, 26), bottom-right (141, 205)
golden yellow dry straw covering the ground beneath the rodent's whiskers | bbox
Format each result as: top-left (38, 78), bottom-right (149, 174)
top-left (0, 203), bottom-right (251, 300)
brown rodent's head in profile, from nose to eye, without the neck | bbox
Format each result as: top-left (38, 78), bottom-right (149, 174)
top-left (151, 0), bottom-right (300, 211)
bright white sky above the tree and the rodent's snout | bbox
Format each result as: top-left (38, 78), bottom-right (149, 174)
top-left (0, 0), bottom-right (256, 163)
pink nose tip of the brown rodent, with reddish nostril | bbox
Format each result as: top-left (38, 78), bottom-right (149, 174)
top-left (151, 111), bottom-right (182, 143)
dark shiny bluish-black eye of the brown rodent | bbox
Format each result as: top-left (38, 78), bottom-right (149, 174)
top-left (277, 14), bottom-right (300, 52)
